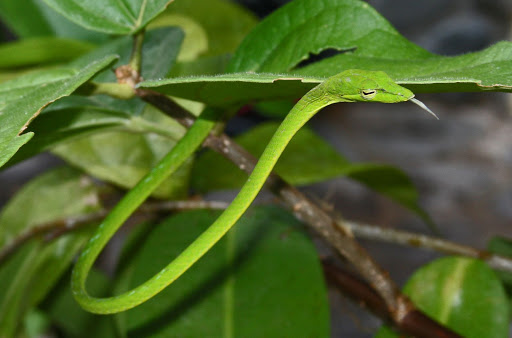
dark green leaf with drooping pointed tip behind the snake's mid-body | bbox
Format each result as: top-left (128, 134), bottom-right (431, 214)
top-left (192, 122), bottom-right (435, 227)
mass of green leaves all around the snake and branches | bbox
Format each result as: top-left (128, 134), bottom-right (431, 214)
top-left (0, 0), bottom-right (512, 337)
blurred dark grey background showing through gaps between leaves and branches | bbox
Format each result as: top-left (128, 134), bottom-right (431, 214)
top-left (0, 0), bottom-right (512, 337)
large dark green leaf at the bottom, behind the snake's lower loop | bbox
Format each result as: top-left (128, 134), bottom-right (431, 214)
top-left (117, 207), bottom-right (329, 337)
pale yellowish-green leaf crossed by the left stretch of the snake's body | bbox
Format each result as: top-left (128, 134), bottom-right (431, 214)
top-left (52, 131), bottom-right (192, 199)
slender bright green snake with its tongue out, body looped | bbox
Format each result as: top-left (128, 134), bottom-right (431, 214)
top-left (71, 69), bottom-right (435, 314)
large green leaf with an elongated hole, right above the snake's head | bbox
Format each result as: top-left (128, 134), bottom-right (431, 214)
top-left (140, 0), bottom-right (512, 105)
